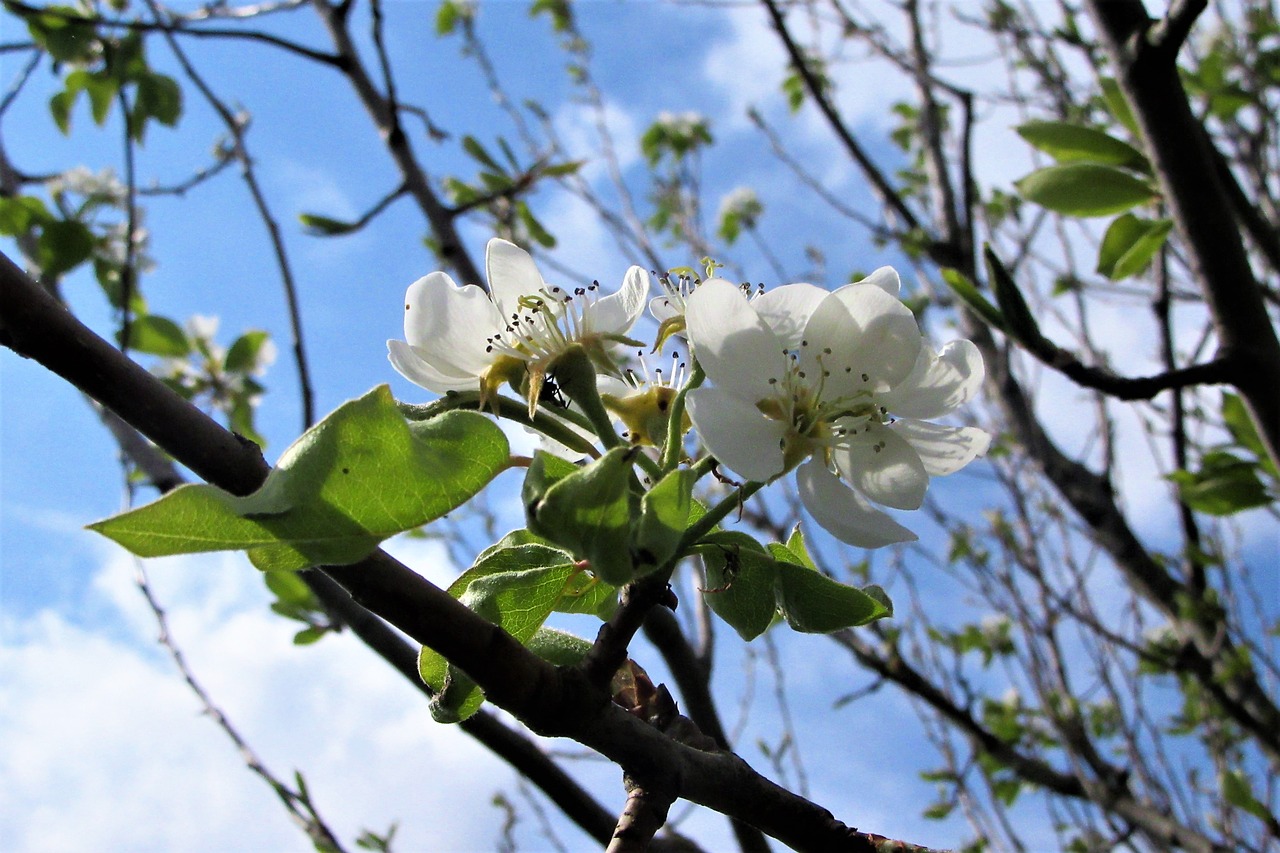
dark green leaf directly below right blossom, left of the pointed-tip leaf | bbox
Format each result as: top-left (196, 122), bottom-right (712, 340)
top-left (701, 530), bottom-right (778, 640)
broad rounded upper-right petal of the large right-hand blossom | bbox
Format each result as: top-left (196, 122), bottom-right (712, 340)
top-left (800, 284), bottom-right (923, 398)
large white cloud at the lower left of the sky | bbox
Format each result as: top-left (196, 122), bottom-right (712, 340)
top-left (0, 544), bottom-right (580, 850)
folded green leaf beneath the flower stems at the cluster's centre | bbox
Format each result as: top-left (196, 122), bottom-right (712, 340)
top-left (525, 447), bottom-right (640, 587)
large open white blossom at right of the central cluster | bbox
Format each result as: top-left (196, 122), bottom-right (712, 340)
top-left (685, 266), bottom-right (991, 548)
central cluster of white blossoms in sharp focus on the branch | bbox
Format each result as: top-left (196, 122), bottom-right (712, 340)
top-left (388, 240), bottom-right (991, 548)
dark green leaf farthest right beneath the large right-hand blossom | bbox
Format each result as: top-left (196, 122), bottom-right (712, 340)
top-left (776, 561), bottom-right (893, 634)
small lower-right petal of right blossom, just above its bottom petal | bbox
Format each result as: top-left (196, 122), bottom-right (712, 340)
top-left (831, 424), bottom-right (929, 510)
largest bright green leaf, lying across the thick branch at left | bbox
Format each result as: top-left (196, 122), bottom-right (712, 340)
top-left (90, 386), bottom-right (509, 571)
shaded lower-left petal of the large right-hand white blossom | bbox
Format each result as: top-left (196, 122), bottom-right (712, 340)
top-left (686, 388), bottom-right (787, 483)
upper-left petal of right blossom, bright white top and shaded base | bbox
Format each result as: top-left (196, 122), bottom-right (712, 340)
top-left (685, 279), bottom-right (787, 405)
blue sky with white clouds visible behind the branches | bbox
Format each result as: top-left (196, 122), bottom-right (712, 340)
top-left (0, 1), bottom-right (1274, 850)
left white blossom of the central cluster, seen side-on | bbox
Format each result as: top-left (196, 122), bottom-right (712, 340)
top-left (387, 238), bottom-right (649, 412)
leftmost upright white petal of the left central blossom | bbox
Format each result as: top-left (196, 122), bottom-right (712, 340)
top-left (404, 273), bottom-right (503, 375)
